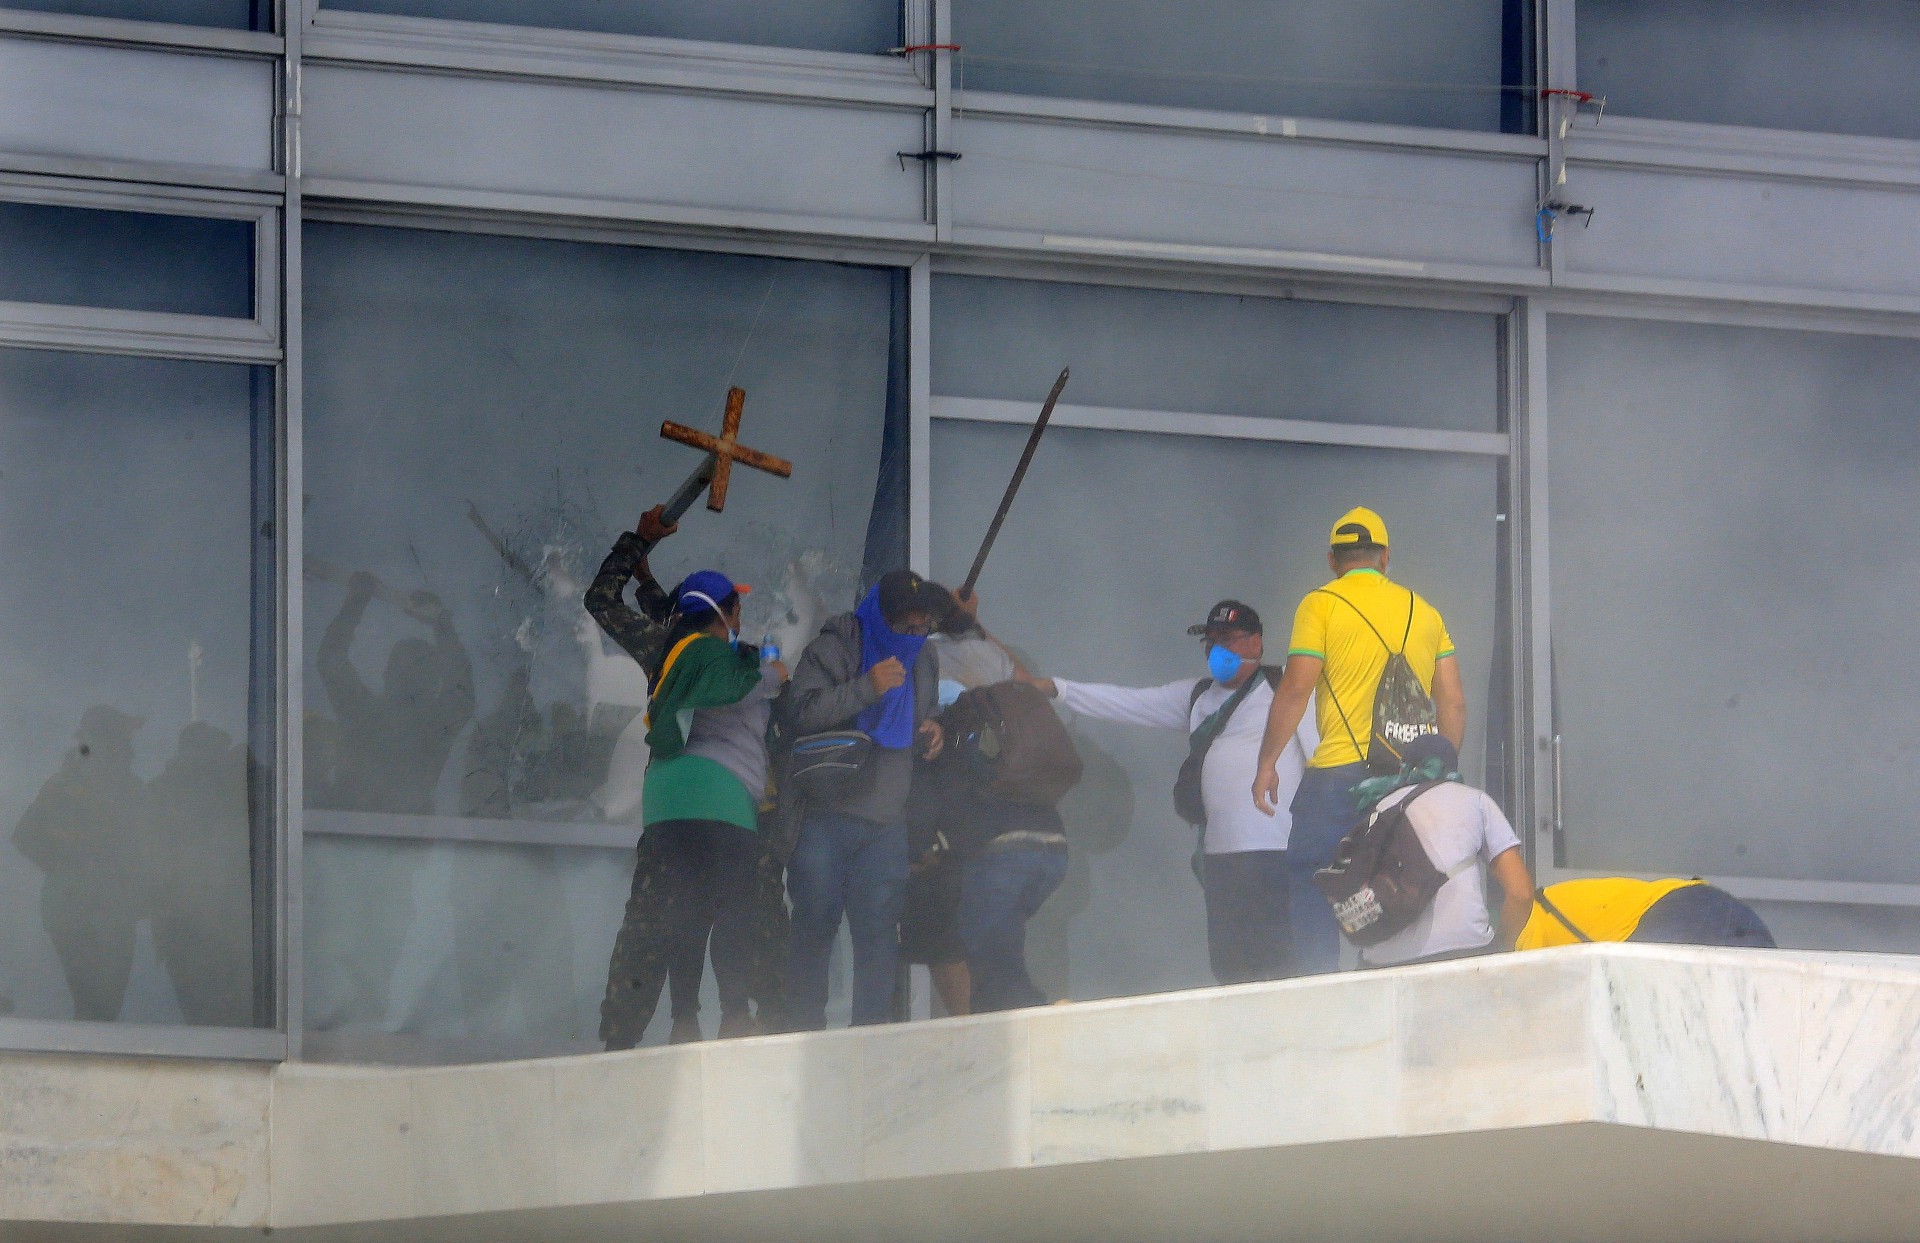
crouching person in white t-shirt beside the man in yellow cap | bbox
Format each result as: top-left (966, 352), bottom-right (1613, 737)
top-left (1359, 734), bottom-right (1534, 966)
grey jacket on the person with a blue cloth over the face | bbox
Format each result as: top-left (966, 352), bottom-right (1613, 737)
top-left (785, 613), bottom-right (941, 824)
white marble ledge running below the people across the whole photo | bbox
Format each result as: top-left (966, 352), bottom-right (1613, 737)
top-left (0, 945), bottom-right (1920, 1228)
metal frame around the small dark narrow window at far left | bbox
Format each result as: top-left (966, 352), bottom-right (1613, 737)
top-left (0, 173), bottom-right (282, 365)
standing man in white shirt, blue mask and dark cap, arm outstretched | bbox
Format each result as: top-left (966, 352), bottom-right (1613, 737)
top-left (1035, 599), bottom-right (1325, 984)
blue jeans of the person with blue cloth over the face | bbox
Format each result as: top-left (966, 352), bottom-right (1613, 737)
top-left (787, 811), bottom-right (906, 1032)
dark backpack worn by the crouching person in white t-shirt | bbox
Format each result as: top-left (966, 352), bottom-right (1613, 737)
top-left (1313, 782), bottom-right (1478, 949)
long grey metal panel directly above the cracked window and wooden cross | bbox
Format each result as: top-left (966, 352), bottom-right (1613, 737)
top-left (301, 65), bottom-right (925, 225)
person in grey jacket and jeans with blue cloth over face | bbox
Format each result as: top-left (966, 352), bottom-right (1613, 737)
top-left (787, 571), bottom-right (952, 1032)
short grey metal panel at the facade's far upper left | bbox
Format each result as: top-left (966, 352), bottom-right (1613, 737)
top-left (0, 37), bottom-right (275, 173)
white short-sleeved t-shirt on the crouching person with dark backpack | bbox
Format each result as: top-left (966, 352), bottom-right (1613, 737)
top-left (1361, 782), bottom-right (1521, 966)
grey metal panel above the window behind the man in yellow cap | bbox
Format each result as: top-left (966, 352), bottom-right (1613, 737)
top-left (954, 115), bottom-right (1538, 275)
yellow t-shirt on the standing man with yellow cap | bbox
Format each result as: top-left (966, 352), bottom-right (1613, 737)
top-left (1286, 569), bottom-right (1453, 768)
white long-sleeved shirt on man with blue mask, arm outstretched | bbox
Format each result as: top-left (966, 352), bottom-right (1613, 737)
top-left (1054, 674), bottom-right (1319, 855)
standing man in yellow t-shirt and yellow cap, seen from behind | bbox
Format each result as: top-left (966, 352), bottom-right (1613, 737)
top-left (1254, 509), bottom-right (1467, 974)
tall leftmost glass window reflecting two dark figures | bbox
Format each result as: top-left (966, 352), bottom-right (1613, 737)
top-left (0, 350), bottom-right (275, 1026)
